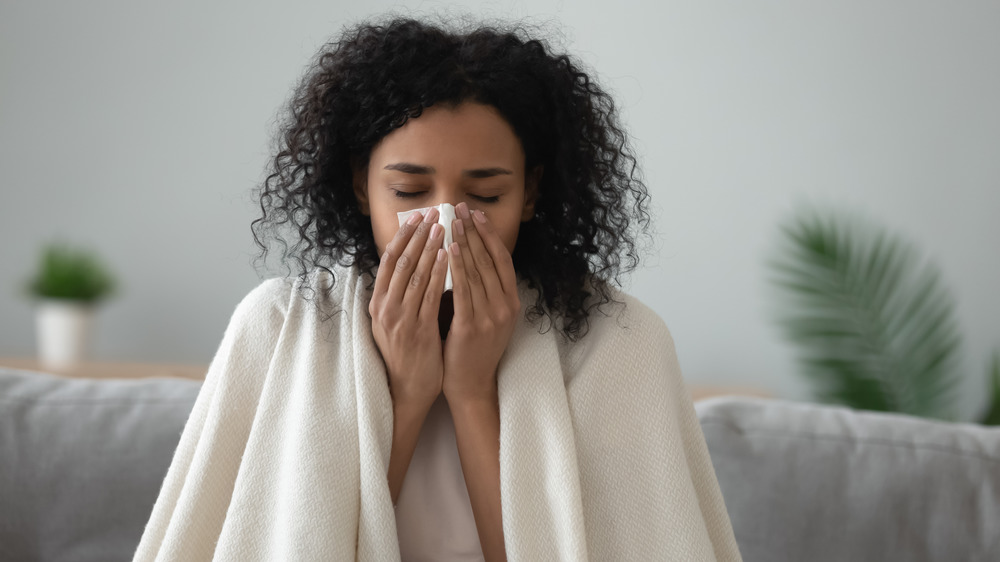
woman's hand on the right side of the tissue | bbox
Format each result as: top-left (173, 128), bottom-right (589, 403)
top-left (442, 203), bottom-right (521, 404)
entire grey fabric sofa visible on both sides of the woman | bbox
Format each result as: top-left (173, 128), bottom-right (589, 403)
top-left (0, 369), bottom-right (1000, 562)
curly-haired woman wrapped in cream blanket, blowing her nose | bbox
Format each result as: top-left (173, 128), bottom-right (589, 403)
top-left (136, 15), bottom-right (739, 561)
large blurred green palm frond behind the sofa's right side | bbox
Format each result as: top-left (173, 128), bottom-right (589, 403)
top-left (770, 211), bottom-right (960, 419)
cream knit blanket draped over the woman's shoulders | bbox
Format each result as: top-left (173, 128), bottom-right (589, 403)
top-left (135, 269), bottom-right (740, 562)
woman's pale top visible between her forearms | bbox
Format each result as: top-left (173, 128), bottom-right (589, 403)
top-left (396, 394), bottom-right (483, 562)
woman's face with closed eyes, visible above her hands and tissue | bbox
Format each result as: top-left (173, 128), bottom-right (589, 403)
top-left (355, 102), bottom-right (541, 255)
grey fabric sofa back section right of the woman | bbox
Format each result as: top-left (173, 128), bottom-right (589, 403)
top-left (695, 397), bottom-right (1000, 562)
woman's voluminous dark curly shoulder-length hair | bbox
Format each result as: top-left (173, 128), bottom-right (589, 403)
top-left (251, 18), bottom-right (649, 341)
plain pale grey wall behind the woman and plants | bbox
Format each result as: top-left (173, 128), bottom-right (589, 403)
top-left (0, 0), bottom-right (1000, 419)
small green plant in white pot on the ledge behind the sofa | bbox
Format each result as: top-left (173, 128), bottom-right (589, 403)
top-left (27, 243), bottom-right (115, 369)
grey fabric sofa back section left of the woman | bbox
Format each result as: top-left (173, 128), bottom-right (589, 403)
top-left (0, 369), bottom-right (201, 562)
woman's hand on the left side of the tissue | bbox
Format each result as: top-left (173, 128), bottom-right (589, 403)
top-left (368, 209), bottom-right (448, 407)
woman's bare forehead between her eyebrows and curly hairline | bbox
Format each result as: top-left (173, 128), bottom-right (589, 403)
top-left (371, 102), bottom-right (524, 170)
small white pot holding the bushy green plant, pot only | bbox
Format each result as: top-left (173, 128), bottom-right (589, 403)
top-left (35, 299), bottom-right (94, 369)
